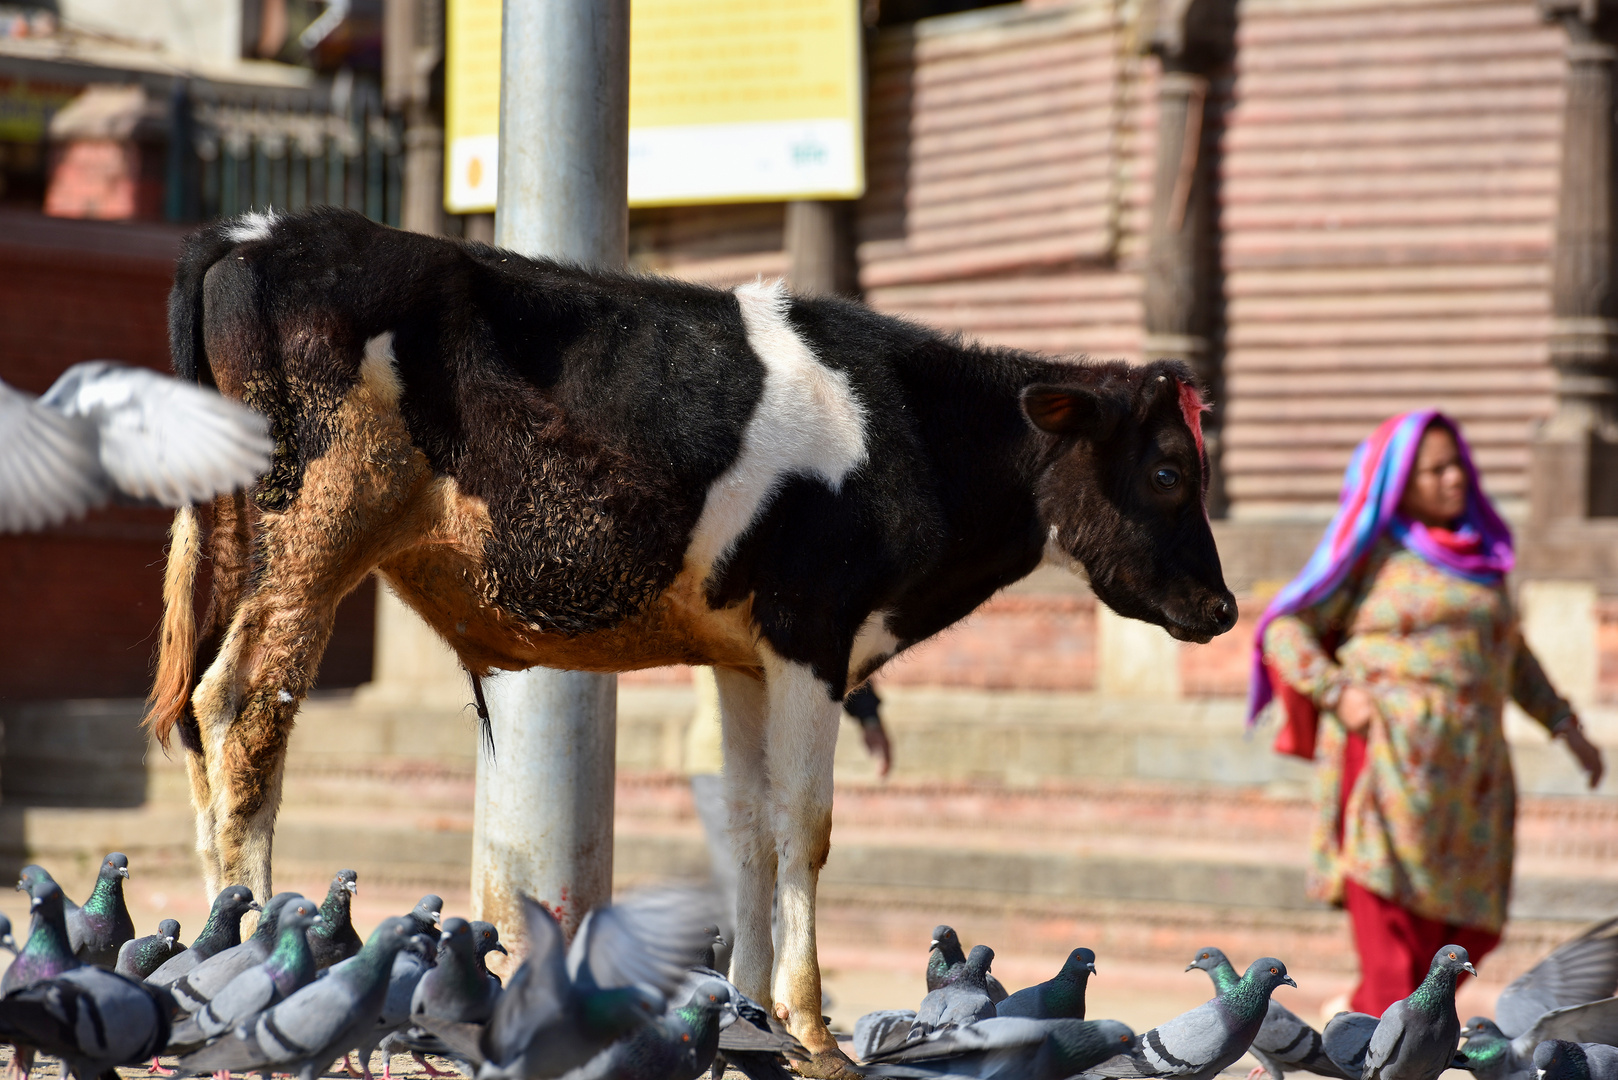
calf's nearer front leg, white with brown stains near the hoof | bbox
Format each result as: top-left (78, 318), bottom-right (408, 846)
top-left (759, 643), bottom-right (848, 1075)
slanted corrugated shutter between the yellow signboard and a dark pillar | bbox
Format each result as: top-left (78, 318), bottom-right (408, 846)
top-left (859, 0), bottom-right (1150, 356)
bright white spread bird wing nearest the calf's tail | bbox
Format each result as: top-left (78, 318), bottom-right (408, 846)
top-left (40, 361), bottom-right (275, 507)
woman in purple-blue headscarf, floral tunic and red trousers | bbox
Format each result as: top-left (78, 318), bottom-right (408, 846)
top-left (1249, 410), bottom-right (1602, 1015)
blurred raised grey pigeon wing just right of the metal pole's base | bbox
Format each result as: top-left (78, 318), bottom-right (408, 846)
top-left (568, 887), bottom-right (714, 997)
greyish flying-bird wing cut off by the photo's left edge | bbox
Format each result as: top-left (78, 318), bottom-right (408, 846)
top-left (0, 382), bottom-right (108, 533)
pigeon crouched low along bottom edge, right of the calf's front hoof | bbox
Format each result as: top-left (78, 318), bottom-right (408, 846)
top-left (861, 1017), bottom-right (1139, 1080)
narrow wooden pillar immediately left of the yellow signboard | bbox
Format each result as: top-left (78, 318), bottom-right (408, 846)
top-left (382, 0), bottom-right (445, 235)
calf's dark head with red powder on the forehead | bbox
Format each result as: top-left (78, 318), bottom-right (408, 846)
top-left (1023, 361), bottom-right (1236, 641)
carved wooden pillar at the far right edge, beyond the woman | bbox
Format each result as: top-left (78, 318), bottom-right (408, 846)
top-left (1529, 0), bottom-right (1618, 526)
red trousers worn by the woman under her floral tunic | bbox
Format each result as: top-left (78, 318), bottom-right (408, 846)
top-left (1338, 735), bottom-right (1500, 1017)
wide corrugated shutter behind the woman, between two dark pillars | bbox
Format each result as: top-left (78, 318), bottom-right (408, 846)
top-left (1222, 0), bottom-right (1563, 517)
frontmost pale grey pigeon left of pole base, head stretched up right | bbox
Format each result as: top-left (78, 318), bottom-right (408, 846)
top-left (180, 918), bottom-right (416, 1080)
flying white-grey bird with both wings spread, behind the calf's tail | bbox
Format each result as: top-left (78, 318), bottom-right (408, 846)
top-left (0, 359), bottom-right (275, 533)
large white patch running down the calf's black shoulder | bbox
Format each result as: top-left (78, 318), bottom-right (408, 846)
top-left (686, 282), bottom-right (866, 573)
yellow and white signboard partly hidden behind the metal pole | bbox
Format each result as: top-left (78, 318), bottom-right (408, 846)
top-left (445, 0), bottom-right (864, 214)
